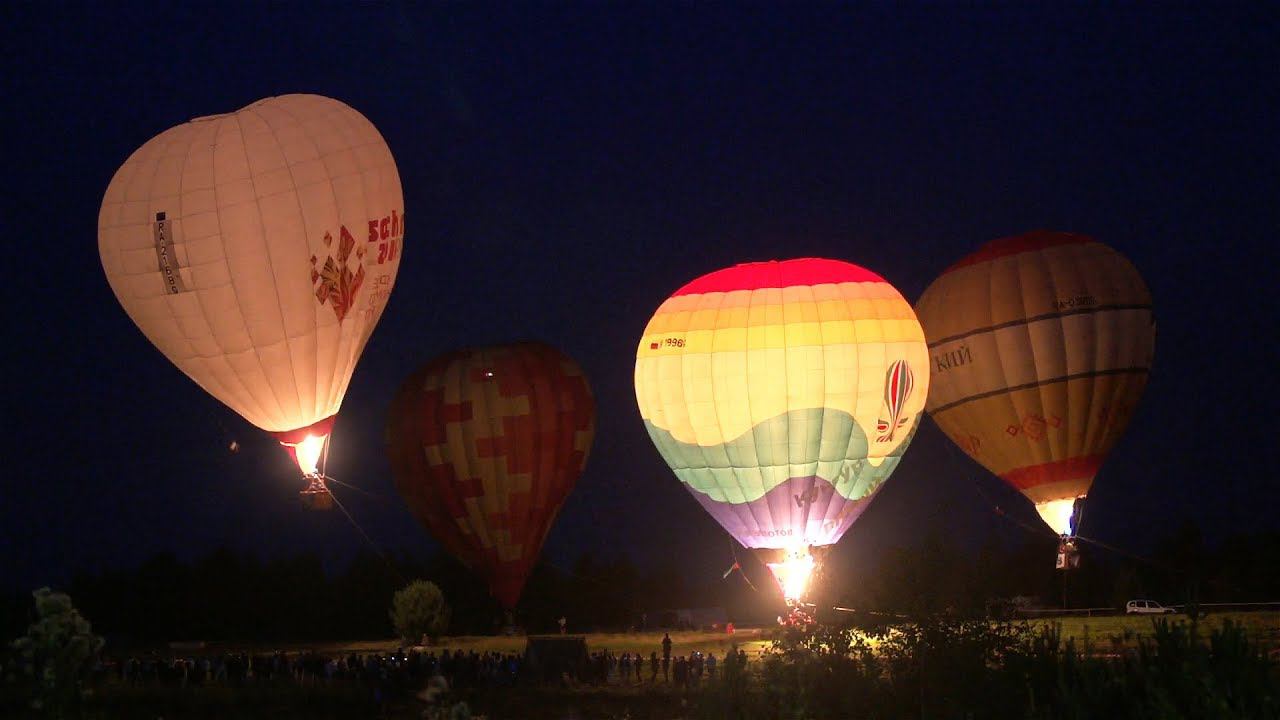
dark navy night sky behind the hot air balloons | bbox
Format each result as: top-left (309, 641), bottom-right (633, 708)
top-left (0, 3), bottom-right (1280, 589)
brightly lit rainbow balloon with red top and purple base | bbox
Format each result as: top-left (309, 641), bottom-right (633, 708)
top-left (635, 258), bottom-right (929, 598)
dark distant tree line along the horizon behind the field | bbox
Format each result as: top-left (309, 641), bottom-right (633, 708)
top-left (0, 524), bottom-right (1280, 644)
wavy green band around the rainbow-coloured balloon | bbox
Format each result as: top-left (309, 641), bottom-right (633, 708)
top-left (644, 407), bottom-right (915, 505)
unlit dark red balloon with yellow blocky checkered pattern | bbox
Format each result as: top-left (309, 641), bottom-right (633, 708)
top-left (387, 342), bottom-right (595, 610)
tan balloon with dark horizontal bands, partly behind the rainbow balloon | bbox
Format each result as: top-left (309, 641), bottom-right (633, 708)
top-left (916, 231), bottom-right (1156, 556)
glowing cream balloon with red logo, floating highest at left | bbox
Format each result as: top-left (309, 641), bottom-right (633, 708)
top-left (99, 95), bottom-right (404, 506)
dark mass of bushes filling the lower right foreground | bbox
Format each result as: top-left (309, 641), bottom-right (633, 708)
top-left (698, 615), bottom-right (1280, 720)
